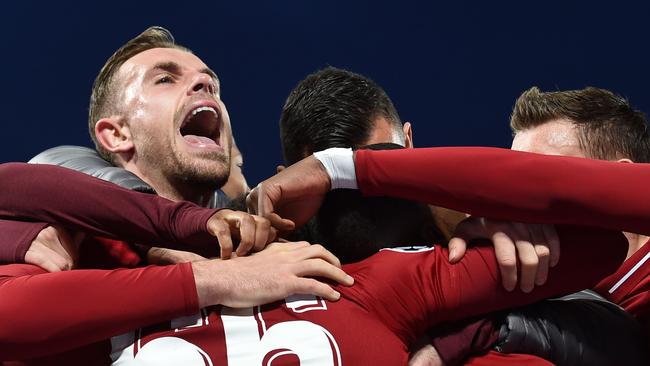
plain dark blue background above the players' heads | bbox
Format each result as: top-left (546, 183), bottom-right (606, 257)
top-left (0, 0), bottom-right (650, 184)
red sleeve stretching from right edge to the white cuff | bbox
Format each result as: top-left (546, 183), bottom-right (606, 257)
top-left (355, 148), bottom-right (650, 235)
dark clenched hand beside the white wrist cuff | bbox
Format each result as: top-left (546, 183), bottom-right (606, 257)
top-left (246, 156), bottom-right (331, 231)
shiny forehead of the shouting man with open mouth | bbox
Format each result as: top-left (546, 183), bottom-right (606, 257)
top-left (118, 48), bottom-right (207, 79)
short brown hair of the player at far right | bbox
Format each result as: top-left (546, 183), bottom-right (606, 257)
top-left (510, 87), bottom-right (650, 163)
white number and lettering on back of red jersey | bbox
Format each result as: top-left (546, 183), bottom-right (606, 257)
top-left (111, 296), bottom-right (342, 366)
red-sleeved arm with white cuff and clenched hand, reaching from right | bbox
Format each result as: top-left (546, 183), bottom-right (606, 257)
top-left (248, 148), bottom-right (650, 234)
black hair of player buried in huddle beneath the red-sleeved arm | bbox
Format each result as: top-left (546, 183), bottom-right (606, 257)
top-left (291, 143), bottom-right (444, 263)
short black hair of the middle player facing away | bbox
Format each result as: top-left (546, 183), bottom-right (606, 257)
top-left (280, 67), bottom-right (404, 165)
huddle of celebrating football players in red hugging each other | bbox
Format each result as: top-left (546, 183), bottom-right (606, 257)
top-left (0, 27), bottom-right (650, 366)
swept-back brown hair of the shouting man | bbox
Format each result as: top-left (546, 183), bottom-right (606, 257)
top-left (88, 27), bottom-right (190, 161)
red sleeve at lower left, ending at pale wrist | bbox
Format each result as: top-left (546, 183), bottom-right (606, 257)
top-left (0, 263), bottom-right (199, 360)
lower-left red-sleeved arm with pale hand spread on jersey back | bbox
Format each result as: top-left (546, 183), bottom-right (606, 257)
top-left (0, 242), bottom-right (353, 360)
